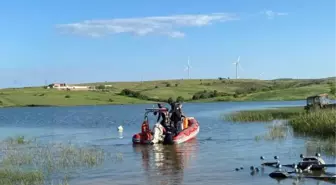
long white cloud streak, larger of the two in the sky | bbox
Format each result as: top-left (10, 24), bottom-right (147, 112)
top-left (56, 13), bottom-right (239, 38)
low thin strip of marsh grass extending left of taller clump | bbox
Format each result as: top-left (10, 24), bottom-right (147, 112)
top-left (224, 107), bottom-right (304, 122)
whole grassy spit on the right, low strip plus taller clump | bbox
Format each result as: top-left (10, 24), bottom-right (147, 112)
top-left (224, 107), bottom-right (336, 138)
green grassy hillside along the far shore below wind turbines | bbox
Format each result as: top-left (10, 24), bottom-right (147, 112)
top-left (0, 78), bottom-right (336, 107)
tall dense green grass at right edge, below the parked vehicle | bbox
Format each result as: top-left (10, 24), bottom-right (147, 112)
top-left (289, 110), bottom-right (336, 137)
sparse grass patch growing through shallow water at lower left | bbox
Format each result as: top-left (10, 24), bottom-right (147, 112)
top-left (0, 137), bottom-right (121, 185)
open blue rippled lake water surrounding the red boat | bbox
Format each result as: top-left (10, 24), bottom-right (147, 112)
top-left (0, 101), bottom-right (334, 185)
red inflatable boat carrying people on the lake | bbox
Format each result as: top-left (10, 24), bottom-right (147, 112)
top-left (132, 108), bottom-right (200, 144)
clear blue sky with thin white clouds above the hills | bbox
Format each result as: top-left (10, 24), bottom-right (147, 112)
top-left (0, 0), bottom-right (336, 87)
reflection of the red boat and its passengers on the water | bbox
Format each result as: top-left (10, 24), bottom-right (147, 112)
top-left (134, 139), bottom-right (198, 185)
